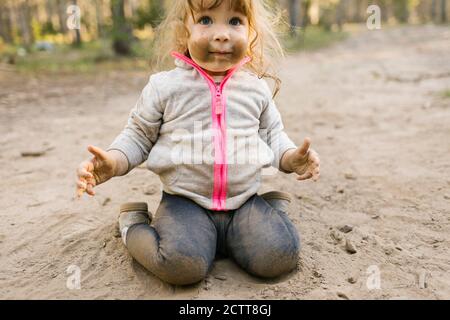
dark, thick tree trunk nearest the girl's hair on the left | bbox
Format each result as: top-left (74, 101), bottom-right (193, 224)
top-left (111, 0), bottom-right (131, 55)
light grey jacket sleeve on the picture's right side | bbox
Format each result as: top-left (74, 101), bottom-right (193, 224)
top-left (259, 80), bottom-right (297, 173)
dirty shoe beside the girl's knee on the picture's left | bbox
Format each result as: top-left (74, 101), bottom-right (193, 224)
top-left (119, 202), bottom-right (152, 245)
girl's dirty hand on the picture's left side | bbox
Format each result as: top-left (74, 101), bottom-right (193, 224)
top-left (76, 145), bottom-right (116, 198)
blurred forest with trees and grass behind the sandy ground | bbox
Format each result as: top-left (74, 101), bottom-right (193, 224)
top-left (0, 0), bottom-right (450, 71)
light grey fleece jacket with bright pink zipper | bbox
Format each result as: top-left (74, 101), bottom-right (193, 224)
top-left (107, 52), bottom-right (297, 211)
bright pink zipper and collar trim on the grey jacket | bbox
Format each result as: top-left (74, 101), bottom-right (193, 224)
top-left (171, 51), bottom-right (251, 211)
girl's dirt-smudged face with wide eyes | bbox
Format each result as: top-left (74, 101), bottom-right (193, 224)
top-left (187, 0), bottom-right (249, 76)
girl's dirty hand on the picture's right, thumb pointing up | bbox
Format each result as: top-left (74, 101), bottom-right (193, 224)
top-left (290, 138), bottom-right (320, 181)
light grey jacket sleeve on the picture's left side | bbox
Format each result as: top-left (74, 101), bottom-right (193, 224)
top-left (107, 77), bottom-right (164, 174)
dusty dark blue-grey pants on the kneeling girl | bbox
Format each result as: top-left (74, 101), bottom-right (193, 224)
top-left (126, 191), bottom-right (300, 285)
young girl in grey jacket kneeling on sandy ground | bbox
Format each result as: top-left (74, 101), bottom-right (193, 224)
top-left (77, 0), bottom-right (319, 285)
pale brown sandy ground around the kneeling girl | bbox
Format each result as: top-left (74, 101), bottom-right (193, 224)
top-left (0, 26), bottom-right (450, 299)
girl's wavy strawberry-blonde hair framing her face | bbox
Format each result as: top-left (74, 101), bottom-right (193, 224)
top-left (151, 0), bottom-right (286, 97)
